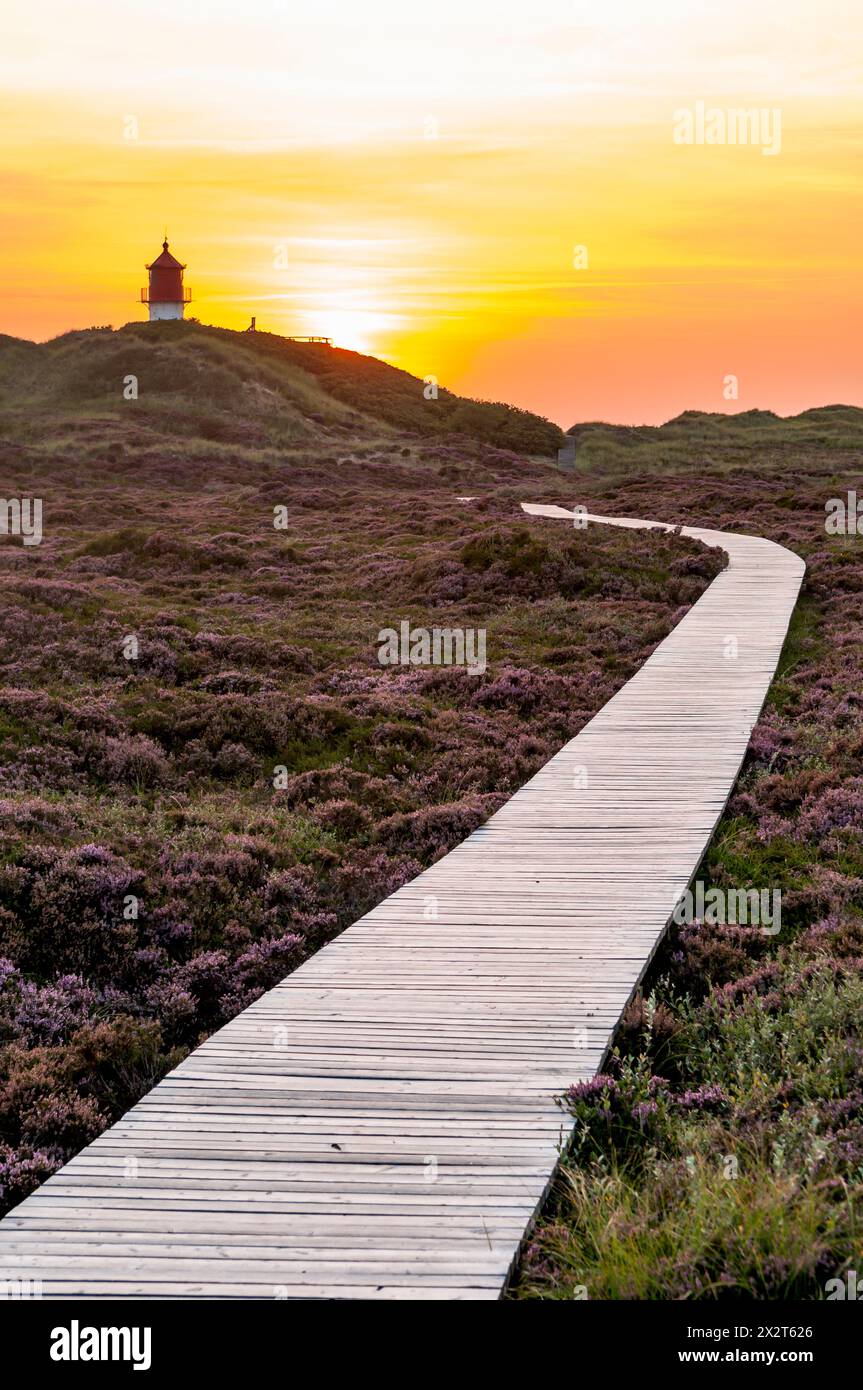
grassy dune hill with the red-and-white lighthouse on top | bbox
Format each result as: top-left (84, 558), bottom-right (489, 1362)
top-left (0, 322), bottom-right (563, 456)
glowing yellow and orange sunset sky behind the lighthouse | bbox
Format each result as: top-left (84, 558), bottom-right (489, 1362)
top-left (0, 0), bottom-right (863, 427)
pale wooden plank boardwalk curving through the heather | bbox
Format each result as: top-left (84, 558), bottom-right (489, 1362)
top-left (0, 507), bottom-right (805, 1300)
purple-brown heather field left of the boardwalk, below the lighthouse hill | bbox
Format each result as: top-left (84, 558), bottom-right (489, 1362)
top-left (0, 428), bottom-right (722, 1207)
